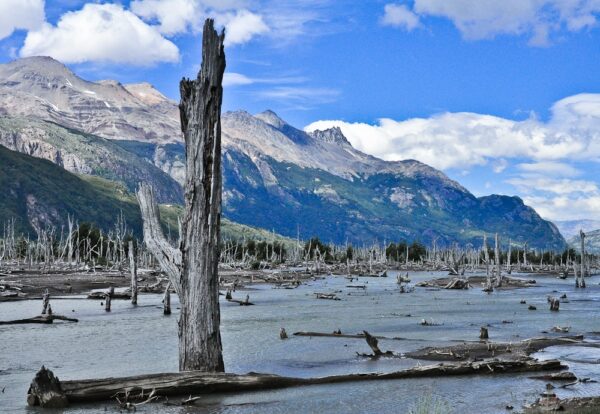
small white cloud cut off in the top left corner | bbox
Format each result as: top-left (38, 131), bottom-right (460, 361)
top-left (0, 0), bottom-right (45, 39)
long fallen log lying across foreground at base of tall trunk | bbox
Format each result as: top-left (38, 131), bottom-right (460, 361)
top-left (27, 359), bottom-right (565, 407)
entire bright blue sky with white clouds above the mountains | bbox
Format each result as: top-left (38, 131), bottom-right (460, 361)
top-left (0, 0), bottom-right (600, 226)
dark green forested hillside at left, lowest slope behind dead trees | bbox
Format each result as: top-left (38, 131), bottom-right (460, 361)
top-left (0, 145), bottom-right (294, 246)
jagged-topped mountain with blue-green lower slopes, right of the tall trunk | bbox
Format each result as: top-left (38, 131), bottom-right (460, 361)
top-left (216, 111), bottom-right (566, 250)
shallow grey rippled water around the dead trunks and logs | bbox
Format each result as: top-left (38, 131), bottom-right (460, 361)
top-left (0, 272), bottom-right (600, 413)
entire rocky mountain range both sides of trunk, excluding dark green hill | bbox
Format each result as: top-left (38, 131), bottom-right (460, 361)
top-left (0, 57), bottom-right (566, 249)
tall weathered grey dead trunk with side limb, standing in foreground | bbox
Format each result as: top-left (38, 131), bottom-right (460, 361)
top-left (138, 19), bottom-right (225, 371)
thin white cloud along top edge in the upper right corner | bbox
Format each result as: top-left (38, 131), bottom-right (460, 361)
top-left (413, 0), bottom-right (600, 46)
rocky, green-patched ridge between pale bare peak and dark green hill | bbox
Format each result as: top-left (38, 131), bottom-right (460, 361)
top-left (0, 117), bottom-right (183, 203)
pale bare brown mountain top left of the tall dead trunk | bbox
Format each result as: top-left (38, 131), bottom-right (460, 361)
top-left (0, 57), bottom-right (181, 143)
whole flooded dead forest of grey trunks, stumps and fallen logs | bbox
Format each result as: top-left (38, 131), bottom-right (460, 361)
top-left (0, 20), bottom-right (600, 412)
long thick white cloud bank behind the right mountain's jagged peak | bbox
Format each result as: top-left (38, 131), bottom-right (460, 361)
top-left (306, 94), bottom-right (600, 169)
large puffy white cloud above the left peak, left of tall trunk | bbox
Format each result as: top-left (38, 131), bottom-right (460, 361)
top-left (20, 3), bottom-right (179, 65)
